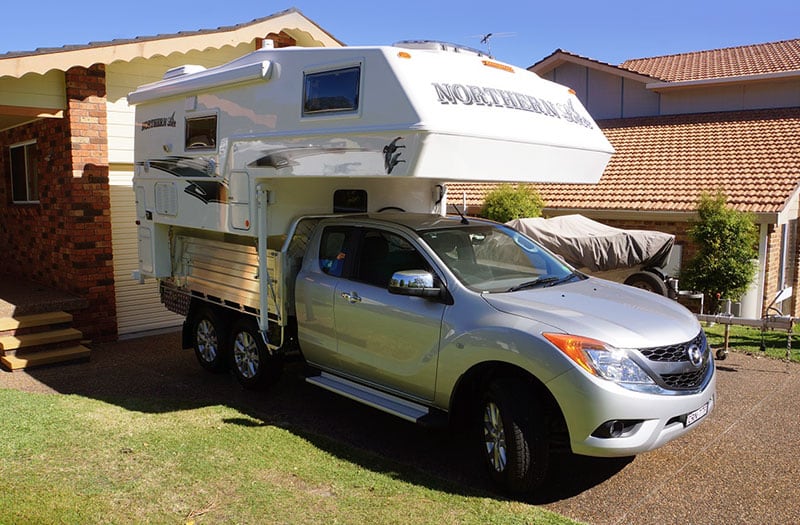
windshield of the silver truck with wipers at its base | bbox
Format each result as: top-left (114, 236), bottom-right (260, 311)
top-left (420, 225), bottom-right (582, 293)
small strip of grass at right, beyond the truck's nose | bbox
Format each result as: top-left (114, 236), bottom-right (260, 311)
top-left (703, 324), bottom-right (800, 362)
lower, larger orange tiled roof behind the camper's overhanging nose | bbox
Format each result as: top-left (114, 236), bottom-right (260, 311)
top-left (449, 108), bottom-right (800, 213)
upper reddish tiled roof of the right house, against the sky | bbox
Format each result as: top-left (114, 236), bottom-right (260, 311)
top-left (620, 39), bottom-right (800, 82)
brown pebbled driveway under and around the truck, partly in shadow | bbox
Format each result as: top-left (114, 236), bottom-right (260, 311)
top-left (0, 333), bottom-right (800, 525)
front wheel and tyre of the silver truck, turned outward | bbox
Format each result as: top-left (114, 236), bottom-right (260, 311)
top-left (478, 379), bottom-right (550, 494)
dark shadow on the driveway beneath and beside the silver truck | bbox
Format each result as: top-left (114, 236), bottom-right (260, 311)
top-left (0, 333), bottom-right (632, 504)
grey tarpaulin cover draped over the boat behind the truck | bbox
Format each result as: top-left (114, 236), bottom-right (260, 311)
top-left (506, 215), bottom-right (675, 272)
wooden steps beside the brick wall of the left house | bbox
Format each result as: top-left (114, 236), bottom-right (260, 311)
top-left (0, 311), bottom-right (91, 372)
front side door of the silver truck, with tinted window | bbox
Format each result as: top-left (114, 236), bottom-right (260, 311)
top-left (333, 229), bottom-right (445, 400)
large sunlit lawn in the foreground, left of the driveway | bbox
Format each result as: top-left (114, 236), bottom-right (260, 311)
top-left (0, 389), bottom-right (575, 525)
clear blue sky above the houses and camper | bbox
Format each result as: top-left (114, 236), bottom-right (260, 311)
top-left (0, 0), bottom-right (800, 67)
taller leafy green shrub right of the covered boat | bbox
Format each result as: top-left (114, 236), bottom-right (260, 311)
top-left (681, 192), bottom-right (758, 312)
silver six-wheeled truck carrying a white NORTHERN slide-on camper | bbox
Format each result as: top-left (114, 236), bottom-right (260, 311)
top-left (129, 42), bottom-right (715, 492)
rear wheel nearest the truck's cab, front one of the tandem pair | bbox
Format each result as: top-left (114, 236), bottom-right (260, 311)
top-left (231, 318), bottom-right (283, 389)
